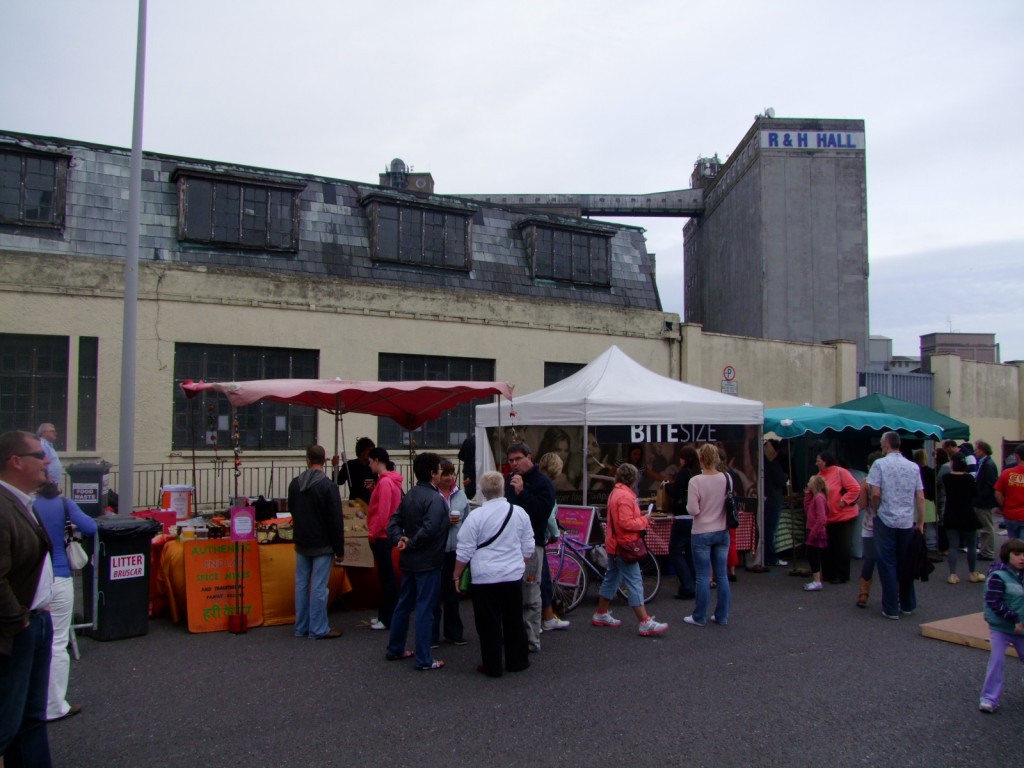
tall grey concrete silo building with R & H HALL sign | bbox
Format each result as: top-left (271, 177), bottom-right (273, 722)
top-left (684, 116), bottom-right (868, 366)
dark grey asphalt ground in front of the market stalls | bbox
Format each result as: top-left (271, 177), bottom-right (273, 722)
top-left (50, 561), bottom-right (1024, 768)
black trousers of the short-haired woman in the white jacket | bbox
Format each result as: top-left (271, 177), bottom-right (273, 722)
top-left (470, 581), bottom-right (529, 677)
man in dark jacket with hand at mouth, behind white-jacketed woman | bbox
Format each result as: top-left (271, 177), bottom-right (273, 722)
top-left (505, 442), bottom-right (555, 653)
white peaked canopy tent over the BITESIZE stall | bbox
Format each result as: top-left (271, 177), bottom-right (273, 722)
top-left (475, 346), bottom-right (764, 562)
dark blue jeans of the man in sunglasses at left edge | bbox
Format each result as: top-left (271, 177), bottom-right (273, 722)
top-left (0, 611), bottom-right (53, 768)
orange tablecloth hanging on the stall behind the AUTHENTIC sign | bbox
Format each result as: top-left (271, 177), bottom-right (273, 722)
top-left (153, 540), bottom-right (352, 627)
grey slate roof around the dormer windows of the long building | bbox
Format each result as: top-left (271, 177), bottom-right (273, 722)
top-left (0, 132), bottom-right (662, 310)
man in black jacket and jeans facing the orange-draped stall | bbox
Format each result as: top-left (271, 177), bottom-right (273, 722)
top-left (288, 445), bottom-right (345, 640)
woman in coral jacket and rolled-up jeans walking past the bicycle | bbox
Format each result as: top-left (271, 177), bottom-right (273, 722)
top-left (591, 464), bottom-right (669, 637)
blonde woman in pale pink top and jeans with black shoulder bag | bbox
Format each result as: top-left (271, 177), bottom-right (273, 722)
top-left (683, 442), bottom-right (732, 627)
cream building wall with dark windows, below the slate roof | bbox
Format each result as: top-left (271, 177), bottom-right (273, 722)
top-left (0, 251), bottom-right (679, 463)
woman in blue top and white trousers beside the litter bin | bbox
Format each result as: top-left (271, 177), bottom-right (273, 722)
top-left (32, 482), bottom-right (96, 721)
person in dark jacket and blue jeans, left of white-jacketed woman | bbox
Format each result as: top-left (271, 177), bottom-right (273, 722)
top-left (385, 454), bottom-right (449, 671)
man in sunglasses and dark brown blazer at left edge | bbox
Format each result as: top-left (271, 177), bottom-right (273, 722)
top-left (0, 432), bottom-right (53, 766)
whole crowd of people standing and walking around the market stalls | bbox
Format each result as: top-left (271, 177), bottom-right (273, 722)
top-left (0, 424), bottom-right (1024, 765)
